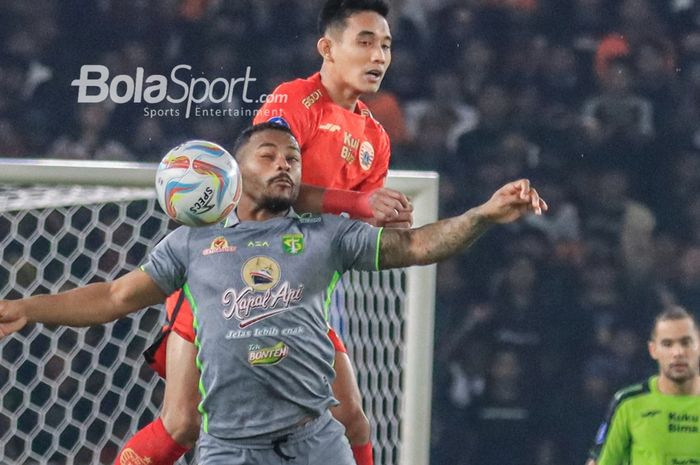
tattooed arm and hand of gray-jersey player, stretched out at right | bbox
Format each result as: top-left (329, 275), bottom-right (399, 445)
top-left (379, 179), bottom-right (548, 269)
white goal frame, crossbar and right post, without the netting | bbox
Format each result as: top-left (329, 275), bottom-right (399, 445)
top-left (0, 159), bottom-right (438, 465)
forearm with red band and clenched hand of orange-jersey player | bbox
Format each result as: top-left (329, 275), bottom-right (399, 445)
top-left (294, 184), bottom-right (413, 228)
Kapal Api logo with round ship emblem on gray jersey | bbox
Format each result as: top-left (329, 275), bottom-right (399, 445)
top-left (221, 255), bottom-right (304, 329)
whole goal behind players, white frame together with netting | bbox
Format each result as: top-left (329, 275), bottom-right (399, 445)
top-left (0, 160), bottom-right (437, 465)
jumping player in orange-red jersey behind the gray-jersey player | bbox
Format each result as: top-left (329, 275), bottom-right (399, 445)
top-left (115, 0), bottom-right (412, 465)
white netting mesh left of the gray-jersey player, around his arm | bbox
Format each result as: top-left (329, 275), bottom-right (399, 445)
top-left (0, 187), bottom-right (174, 464)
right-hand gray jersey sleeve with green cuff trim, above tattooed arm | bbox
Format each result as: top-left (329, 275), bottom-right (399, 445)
top-left (324, 217), bottom-right (383, 271)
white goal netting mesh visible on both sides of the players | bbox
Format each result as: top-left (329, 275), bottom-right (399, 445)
top-left (0, 183), bottom-right (410, 465)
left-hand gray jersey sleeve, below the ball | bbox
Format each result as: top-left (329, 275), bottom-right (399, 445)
top-left (141, 227), bottom-right (190, 295)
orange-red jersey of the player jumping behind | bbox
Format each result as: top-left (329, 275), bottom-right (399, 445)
top-left (253, 73), bottom-right (391, 192)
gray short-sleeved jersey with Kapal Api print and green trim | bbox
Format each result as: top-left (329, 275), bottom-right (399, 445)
top-left (143, 213), bottom-right (381, 438)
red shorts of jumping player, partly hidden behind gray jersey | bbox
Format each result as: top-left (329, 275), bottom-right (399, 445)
top-left (143, 290), bottom-right (348, 378)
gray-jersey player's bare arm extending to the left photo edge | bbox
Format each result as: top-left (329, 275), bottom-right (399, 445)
top-left (0, 270), bottom-right (165, 338)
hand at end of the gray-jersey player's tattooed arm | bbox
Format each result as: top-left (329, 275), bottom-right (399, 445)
top-left (476, 179), bottom-right (549, 224)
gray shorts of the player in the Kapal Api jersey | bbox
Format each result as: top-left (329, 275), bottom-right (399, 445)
top-left (198, 411), bottom-right (355, 465)
